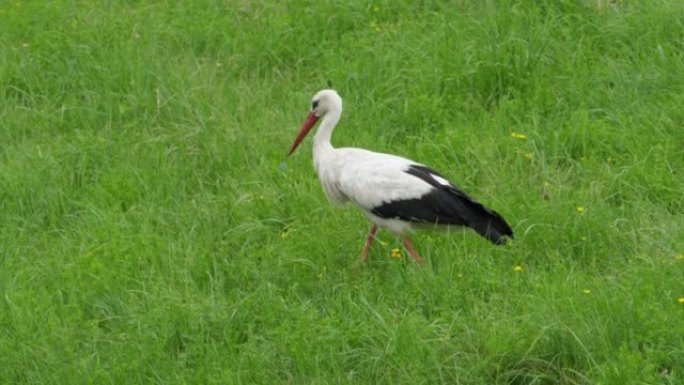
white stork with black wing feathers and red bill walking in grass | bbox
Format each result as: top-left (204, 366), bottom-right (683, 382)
top-left (287, 90), bottom-right (513, 266)
